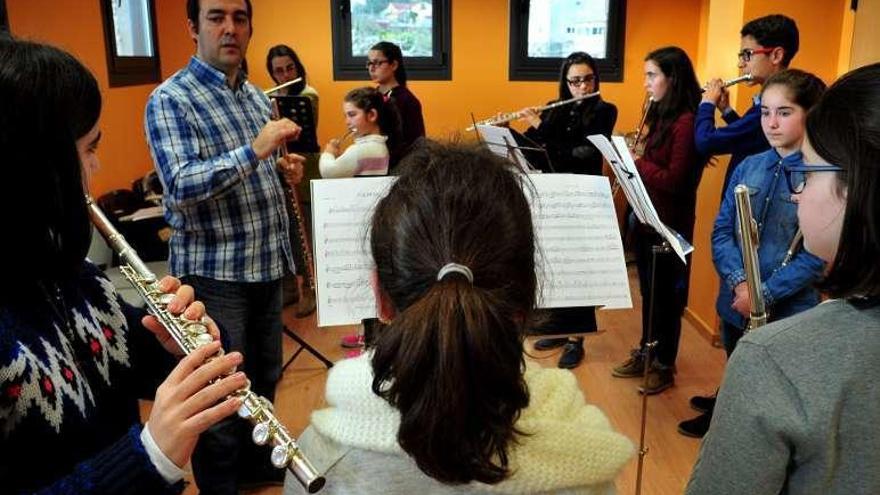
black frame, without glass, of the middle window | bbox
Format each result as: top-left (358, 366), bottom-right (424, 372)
top-left (330, 0), bottom-right (452, 81)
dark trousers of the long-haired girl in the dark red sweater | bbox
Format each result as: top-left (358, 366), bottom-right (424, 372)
top-left (634, 230), bottom-right (690, 366)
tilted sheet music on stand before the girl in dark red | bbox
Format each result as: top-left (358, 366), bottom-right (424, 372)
top-left (587, 134), bottom-right (694, 264)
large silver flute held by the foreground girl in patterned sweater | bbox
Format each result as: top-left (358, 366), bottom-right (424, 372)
top-left (86, 196), bottom-right (326, 493)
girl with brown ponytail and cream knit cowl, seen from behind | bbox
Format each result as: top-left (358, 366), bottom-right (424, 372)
top-left (285, 144), bottom-right (633, 494)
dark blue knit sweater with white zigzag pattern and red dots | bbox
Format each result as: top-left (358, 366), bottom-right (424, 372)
top-left (0, 262), bottom-right (182, 494)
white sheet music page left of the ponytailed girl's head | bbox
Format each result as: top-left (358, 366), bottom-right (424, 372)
top-left (311, 177), bottom-right (394, 327)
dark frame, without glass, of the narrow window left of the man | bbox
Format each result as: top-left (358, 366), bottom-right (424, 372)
top-left (101, 0), bottom-right (162, 88)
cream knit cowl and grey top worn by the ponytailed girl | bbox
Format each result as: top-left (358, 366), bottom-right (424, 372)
top-left (285, 354), bottom-right (634, 495)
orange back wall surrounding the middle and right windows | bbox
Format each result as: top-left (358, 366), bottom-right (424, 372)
top-left (248, 0), bottom-right (700, 141)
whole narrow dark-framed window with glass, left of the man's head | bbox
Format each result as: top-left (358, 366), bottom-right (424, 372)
top-left (101, 0), bottom-right (161, 87)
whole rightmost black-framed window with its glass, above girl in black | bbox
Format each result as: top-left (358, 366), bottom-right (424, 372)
top-left (509, 0), bottom-right (626, 82)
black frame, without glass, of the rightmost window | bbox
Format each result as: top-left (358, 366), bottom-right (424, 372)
top-left (508, 0), bottom-right (626, 82)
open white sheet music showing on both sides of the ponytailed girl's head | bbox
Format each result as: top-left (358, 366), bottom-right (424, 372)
top-left (311, 174), bottom-right (632, 326)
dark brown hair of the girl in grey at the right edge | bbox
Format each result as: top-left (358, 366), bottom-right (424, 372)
top-left (807, 64), bottom-right (880, 299)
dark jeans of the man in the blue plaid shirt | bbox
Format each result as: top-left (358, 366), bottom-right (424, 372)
top-left (181, 275), bottom-right (282, 495)
